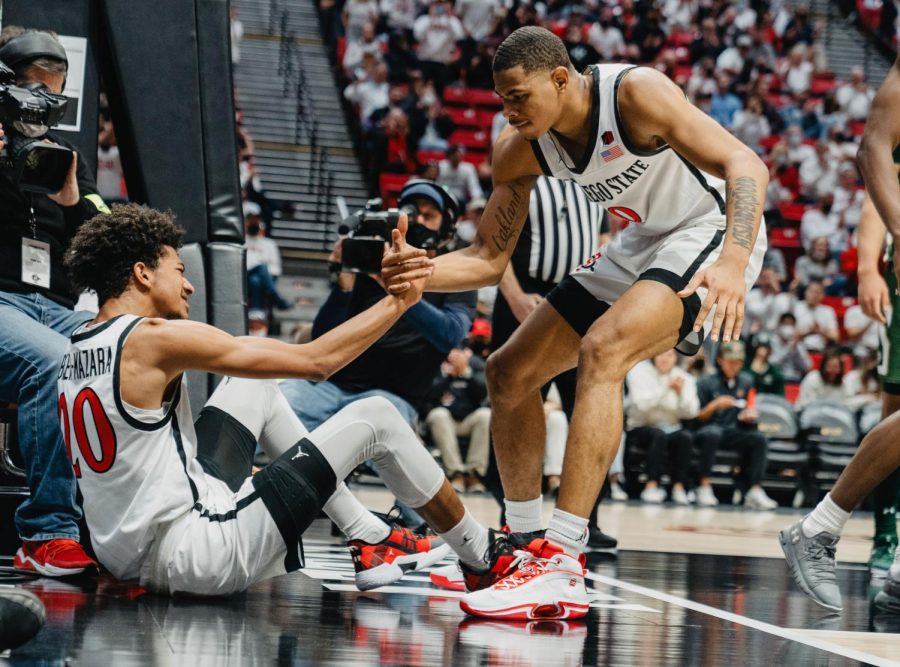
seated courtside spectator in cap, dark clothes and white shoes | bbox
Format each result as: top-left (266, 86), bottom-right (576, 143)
top-left (695, 341), bottom-right (778, 510)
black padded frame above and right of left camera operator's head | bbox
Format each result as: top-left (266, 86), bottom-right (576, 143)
top-left (0, 0), bottom-right (100, 175)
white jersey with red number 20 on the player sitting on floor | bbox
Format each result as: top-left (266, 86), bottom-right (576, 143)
top-left (57, 315), bottom-right (207, 579)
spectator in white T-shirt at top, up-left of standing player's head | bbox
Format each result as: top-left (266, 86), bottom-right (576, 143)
top-left (413, 0), bottom-right (466, 96)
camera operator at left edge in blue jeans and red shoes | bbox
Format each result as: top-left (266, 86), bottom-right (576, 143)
top-left (0, 26), bottom-right (107, 576)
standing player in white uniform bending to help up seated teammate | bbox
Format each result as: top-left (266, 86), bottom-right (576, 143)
top-left (383, 27), bottom-right (768, 618)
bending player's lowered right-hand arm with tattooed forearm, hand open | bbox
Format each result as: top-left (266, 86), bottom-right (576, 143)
top-left (618, 67), bottom-right (769, 341)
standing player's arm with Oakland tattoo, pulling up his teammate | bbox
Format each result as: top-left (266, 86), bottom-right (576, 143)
top-left (381, 127), bottom-right (541, 293)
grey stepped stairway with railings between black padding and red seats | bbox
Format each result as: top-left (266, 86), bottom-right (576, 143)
top-left (234, 0), bottom-right (366, 259)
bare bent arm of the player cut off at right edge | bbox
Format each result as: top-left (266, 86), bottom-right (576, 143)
top-left (856, 56), bottom-right (900, 239)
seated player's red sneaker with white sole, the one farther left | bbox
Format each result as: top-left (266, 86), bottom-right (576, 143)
top-left (347, 524), bottom-right (450, 591)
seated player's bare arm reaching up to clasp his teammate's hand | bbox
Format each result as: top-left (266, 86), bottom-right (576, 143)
top-left (125, 216), bottom-right (432, 381)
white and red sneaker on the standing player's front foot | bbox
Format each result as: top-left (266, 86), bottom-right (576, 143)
top-left (459, 539), bottom-right (590, 621)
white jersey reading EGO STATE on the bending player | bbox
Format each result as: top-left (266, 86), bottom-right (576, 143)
top-left (531, 65), bottom-right (725, 235)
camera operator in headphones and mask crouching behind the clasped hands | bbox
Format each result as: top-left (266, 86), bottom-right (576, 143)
top-left (280, 180), bottom-right (477, 524)
